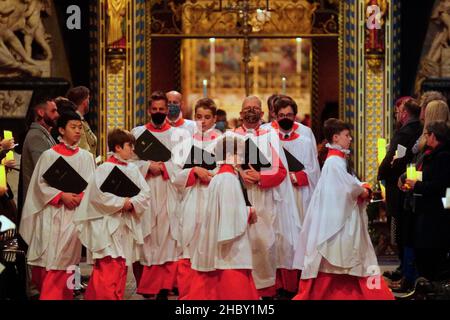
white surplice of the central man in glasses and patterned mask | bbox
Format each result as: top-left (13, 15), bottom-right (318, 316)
top-left (236, 128), bottom-right (301, 289)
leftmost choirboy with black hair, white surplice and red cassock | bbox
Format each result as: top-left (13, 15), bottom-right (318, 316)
top-left (20, 112), bottom-right (95, 300)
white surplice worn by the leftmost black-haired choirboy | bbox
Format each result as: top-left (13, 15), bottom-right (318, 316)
top-left (20, 147), bottom-right (95, 270)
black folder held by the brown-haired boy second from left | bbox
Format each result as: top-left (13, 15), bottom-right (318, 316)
top-left (100, 166), bottom-right (141, 198)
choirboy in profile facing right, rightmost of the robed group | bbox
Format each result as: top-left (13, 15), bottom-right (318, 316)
top-left (294, 118), bottom-right (394, 300)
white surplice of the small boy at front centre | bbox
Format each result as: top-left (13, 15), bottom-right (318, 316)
top-left (191, 172), bottom-right (253, 272)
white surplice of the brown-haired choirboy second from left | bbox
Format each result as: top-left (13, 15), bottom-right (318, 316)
top-left (74, 158), bottom-right (152, 265)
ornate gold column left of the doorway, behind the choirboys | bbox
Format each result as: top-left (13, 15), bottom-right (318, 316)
top-left (98, 0), bottom-right (137, 156)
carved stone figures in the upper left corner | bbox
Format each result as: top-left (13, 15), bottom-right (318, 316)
top-left (0, 0), bottom-right (52, 77)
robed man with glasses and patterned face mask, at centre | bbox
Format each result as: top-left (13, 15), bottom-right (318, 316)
top-left (235, 96), bottom-right (301, 297)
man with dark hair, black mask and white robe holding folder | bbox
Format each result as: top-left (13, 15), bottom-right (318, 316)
top-left (132, 92), bottom-right (190, 299)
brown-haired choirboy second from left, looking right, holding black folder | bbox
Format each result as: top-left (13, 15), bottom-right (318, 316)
top-left (74, 129), bottom-right (152, 300)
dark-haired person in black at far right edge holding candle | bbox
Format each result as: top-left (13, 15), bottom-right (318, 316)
top-left (405, 121), bottom-right (450, 281)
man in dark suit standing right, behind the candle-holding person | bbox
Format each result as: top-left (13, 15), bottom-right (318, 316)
top-left (378, 97), bottom-right (422, 284)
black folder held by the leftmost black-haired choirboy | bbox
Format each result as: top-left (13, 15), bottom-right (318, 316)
top-left (42, 157), bottom-right (88, 194)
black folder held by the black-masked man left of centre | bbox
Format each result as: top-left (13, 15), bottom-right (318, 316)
top-left (134, 130), bottom-right (172, 162)
